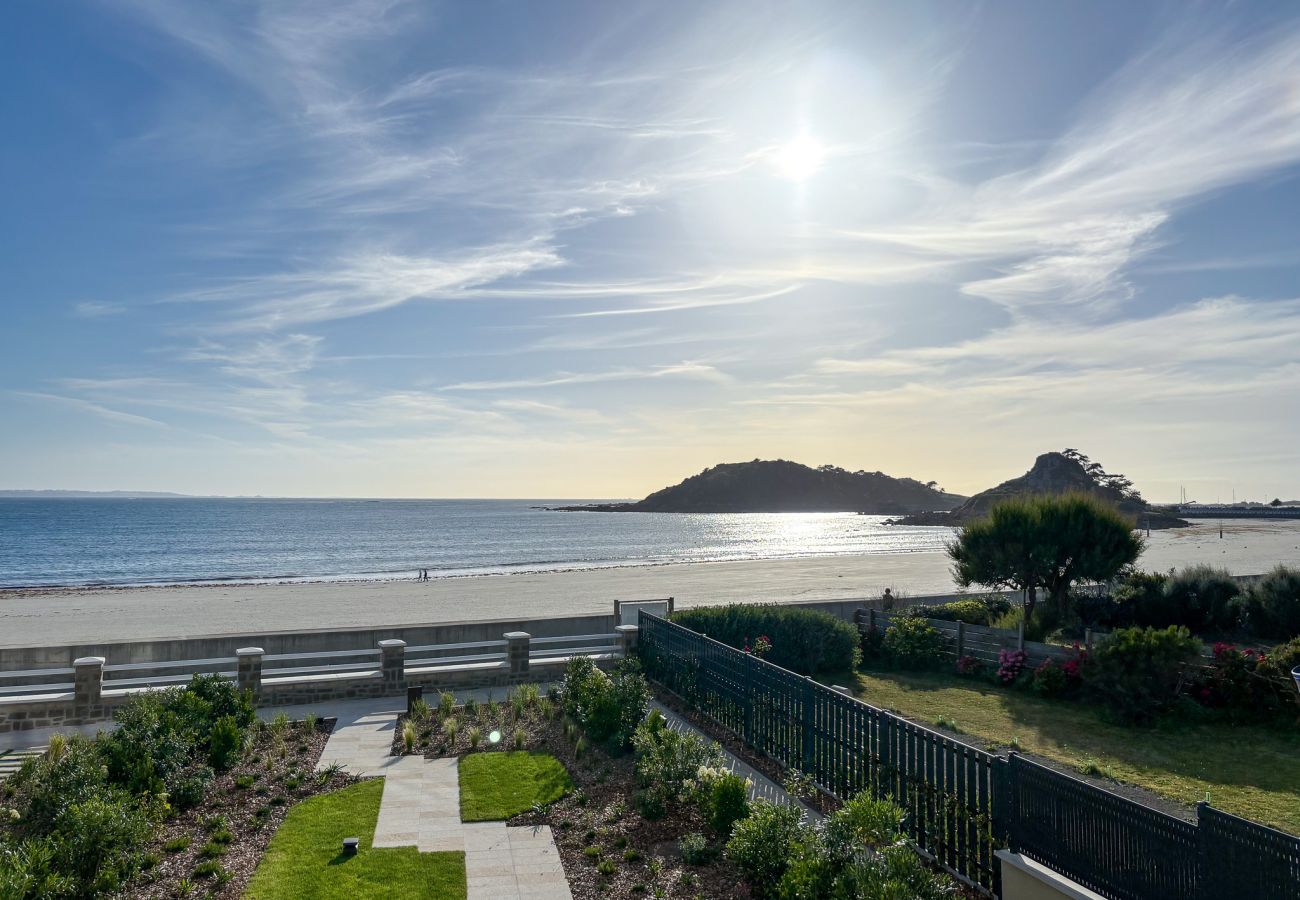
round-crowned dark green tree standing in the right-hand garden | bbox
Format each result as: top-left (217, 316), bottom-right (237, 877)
top-left (948, 493), bottom-right (1143, 622)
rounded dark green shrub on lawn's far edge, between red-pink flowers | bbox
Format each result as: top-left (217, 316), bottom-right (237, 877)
top-left (1083, 626), bottom-right (1201, 722)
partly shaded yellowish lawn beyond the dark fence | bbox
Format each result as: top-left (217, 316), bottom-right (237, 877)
top-left (827, 671), bottom-right (1300, 834)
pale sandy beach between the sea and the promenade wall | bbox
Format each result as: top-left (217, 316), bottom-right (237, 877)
top-left (0, 520), bottom-right (1300, 646)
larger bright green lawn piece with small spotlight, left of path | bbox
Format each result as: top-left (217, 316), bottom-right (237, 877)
top-left (244, 779), bottom-right (465, 900)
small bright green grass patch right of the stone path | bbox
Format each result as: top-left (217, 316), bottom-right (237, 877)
top-left (460, 750), bottom-right (573, 822)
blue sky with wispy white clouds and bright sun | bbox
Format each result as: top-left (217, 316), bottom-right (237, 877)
top-left (0, 0), bottom-right (1300, 502)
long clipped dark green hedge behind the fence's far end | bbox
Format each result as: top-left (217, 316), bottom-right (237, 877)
top-left (672, 603), bottom-right (861, 675)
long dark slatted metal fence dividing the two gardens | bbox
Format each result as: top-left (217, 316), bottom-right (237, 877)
top-left (638, 611), bottom-right (1300, 900)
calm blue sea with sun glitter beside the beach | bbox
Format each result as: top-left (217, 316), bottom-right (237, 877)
top-left (0, 498), bottom-right (950, 587)
